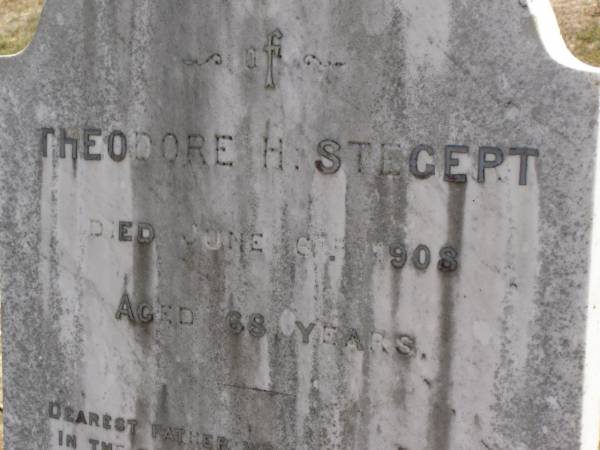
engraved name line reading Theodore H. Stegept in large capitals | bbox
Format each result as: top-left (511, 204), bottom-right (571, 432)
top-left (38, 126), bottom-right (540, 186)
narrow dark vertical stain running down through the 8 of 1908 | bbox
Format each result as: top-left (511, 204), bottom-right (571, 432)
top-left (427, 184), bottom-right (467, 450)
